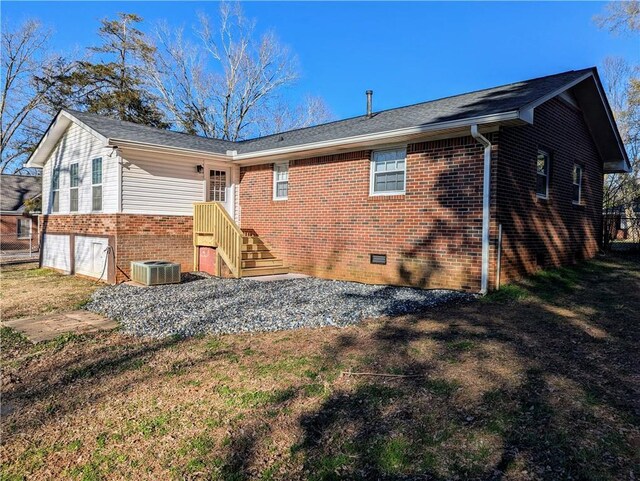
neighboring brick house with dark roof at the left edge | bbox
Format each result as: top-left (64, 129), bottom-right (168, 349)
top-left (0, 174), bottom-right (42, 253)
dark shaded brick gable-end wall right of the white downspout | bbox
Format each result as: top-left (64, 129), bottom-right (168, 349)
top-left (496, 99), bottom-right (603, 281)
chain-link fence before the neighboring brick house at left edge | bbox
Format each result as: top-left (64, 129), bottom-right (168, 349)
top-left (0, 215), bottom-right (40, 263)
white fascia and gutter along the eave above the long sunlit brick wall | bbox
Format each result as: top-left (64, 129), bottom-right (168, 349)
top-left (233, 111), bottom-right (526, 164)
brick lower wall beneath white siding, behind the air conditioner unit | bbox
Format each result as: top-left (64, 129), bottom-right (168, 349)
top-left (40, 214), bottom-right (193, 282)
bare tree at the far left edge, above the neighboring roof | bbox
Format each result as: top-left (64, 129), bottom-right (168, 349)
top-left (0, 20), bottom-right (67, 173)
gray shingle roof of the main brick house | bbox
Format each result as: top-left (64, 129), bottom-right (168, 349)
top-left (62, 69), bottom-right (592, 154)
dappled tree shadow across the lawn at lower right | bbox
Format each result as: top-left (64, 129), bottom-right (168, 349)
top-left (218, 253), bottom-right (640, 480)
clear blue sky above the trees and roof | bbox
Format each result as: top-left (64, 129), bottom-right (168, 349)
top-left (2, 1), bottom-right (640, 118)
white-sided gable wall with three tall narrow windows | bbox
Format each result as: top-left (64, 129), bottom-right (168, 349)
top-left (42, 123), bottom-right (119, 214)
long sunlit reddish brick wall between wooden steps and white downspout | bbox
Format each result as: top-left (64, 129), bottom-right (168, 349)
top-left (239, 137), bottom-right (492, 290)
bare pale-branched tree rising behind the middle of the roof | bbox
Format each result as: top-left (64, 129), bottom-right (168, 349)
top-left (148, 3), bottom-right (328, 140)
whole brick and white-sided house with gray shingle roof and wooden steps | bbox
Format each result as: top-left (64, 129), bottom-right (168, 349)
top-left (27, 68), bottom-right (629, 291)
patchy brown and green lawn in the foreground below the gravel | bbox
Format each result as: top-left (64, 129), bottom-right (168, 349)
top-left (0, 253), bottom-right (640, 480)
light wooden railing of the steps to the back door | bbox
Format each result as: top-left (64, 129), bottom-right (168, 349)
top-left (193, 202), bottom-right (243, 278)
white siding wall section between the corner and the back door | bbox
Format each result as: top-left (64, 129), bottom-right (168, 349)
top-left (122, 154), bottom-right (206, 215)
